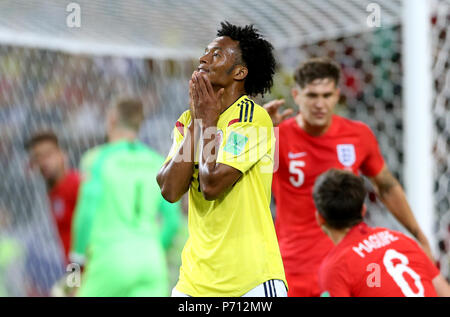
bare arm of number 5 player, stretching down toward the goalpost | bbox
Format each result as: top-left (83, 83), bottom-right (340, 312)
top-left (370, 164), bottom-right (433, 259)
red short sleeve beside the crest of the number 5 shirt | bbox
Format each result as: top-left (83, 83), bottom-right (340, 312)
top-left (360, 125), bottom-right (384, 177)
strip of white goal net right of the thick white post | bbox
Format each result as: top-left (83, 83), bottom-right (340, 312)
top-left (431, 0), bottom-right (450, 279)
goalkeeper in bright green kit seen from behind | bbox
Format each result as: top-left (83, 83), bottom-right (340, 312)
top-left (71, 100), bottom-right (181, 296)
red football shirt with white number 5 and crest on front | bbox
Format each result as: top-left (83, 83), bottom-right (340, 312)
top-left (272, 115), bottom-right (384, 276)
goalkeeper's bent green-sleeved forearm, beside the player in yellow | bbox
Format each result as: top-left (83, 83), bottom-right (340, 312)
top-left (159, 199), bottom-right (181, 250)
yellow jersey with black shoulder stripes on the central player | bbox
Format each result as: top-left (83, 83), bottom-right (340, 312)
top-left (166, 95), bottom-right (287, 297)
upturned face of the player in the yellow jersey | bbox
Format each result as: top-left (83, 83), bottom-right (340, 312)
top-left (197, 36), bottom-right (240, 88)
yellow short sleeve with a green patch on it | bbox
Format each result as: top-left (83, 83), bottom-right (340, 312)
top-left (217, 110), bottom-right (275, 173)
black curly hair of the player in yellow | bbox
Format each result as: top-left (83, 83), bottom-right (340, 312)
top-left (217, 21), bottom-right (276, 96)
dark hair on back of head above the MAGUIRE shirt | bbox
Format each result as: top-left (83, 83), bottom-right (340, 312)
top-left (313, 169), bottom-right (366, 229)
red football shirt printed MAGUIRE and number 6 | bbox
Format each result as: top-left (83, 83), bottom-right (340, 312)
top-left (319, 223), bottom-right (439, 297)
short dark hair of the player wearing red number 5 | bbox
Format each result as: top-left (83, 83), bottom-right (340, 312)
top-left (294, 57), bottom-right (341, 88)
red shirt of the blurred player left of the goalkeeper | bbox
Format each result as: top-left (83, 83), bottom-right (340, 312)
top-left (48, 170), bottom-right (81, 261)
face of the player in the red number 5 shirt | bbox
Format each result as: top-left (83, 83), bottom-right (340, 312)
top-left (292, 78), bottom-right (340, 128)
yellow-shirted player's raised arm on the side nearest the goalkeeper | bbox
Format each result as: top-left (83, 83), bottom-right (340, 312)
top-left (156, 120), bottom-right (195, 203)
